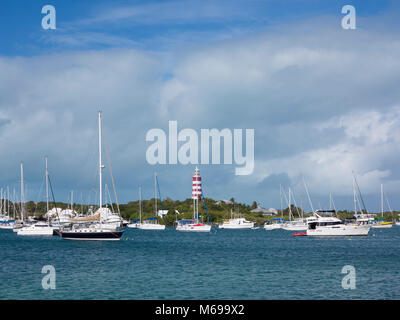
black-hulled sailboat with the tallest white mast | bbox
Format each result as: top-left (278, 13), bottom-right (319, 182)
top-left (60, 112), bottom-right (124, 241)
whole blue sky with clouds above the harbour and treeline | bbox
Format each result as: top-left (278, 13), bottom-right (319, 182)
top-left (0, 0), bottom-right (400, 211)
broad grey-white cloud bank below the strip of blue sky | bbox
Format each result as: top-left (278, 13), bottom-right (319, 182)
top-left (0, 15), bottom-right (400, 207)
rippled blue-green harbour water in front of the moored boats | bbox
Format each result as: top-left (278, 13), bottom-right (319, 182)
top-left (0, 226), bottom-right (400, 299)
